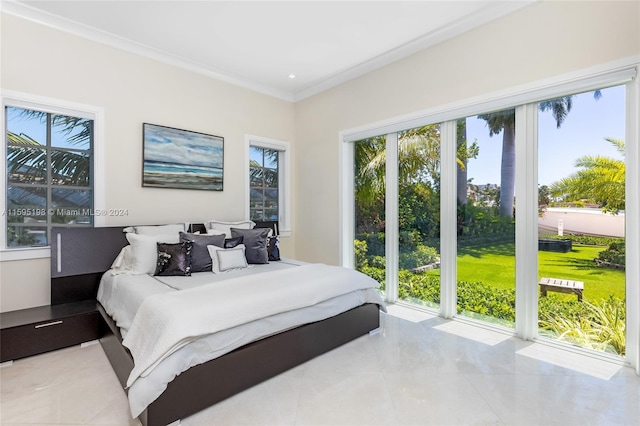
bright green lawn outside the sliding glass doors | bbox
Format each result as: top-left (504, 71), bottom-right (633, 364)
top-left (434, 243), bottom-right (625, 301)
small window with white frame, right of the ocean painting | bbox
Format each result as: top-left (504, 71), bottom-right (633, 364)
top-left (245, 135), bottom-right (290, 236)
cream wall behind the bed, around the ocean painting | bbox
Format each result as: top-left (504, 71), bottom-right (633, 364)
top-left (0, 14), bottom-right (295, 312)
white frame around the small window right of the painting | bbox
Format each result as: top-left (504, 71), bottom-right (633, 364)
top-left (244, 134), bottom-right (291, 237)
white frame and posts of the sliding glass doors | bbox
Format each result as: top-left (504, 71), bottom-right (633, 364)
top-left (338, 56), bottom-right (640, 374)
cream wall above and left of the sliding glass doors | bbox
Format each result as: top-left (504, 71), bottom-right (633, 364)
top-left (294, 1), bottom-right (640, 264)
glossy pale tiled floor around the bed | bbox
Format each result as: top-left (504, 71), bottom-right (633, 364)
top-left (0, 306), bottom-right (640, 426)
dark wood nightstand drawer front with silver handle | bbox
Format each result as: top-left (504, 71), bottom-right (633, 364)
top-left (0, 311), bottom-right (102, 362)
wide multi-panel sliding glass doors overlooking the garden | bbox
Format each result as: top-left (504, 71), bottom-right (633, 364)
top-left (343, 66), bottom-right (640, 365)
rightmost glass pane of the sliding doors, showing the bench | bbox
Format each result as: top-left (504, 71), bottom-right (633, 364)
top-left (537, 86), bottom-right (626, 356)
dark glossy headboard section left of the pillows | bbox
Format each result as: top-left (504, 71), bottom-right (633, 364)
top-left (51, 226), bottom-right (128, 305)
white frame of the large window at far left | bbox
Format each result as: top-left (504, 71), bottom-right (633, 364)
top-left (0, 90), bottom-right (106, 262)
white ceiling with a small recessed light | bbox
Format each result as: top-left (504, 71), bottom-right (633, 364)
top-left (2, 0), bottom-right (535, 101)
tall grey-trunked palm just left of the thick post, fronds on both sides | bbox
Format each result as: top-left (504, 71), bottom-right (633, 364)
top-left (478, 90), bottom-right (602, 217)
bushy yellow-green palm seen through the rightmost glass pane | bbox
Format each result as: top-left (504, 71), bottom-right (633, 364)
top-left (550, 138), bottom-right (625, 214)
